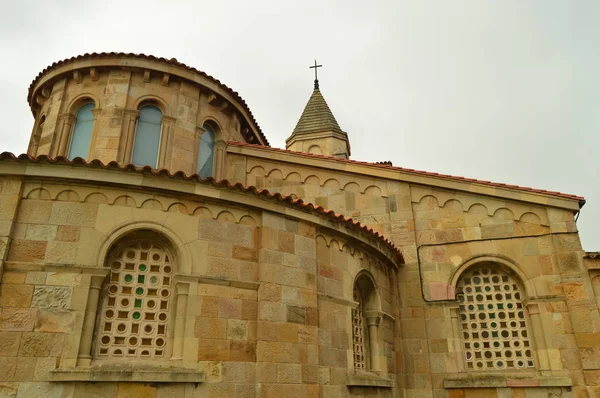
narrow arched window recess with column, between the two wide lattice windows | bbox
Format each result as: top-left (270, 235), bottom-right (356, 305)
top-left (351, 272), bottom-right (381, 371)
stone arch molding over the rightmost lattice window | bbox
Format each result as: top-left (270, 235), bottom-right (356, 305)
top-left (447, 254), bottom-right (538, 300)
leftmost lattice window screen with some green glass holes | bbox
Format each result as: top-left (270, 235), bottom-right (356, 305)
top-left (96, 240), bottom-right (173, 358)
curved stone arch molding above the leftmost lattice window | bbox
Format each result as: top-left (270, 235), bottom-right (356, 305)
top-left (95, 221), bottom-right (192, 274)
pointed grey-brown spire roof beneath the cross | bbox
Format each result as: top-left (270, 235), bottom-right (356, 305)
top-left (292, 86), bottom-right (343, 135)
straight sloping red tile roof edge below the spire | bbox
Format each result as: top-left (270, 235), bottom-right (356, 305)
top-left (228, 141), bottom-right (585, 203)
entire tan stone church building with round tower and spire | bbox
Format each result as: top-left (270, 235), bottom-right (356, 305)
top-left (0, 53), bottom-right (600, 398)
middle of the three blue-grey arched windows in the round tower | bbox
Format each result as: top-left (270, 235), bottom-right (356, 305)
top-left (131, 105), bottom-right (162, 168)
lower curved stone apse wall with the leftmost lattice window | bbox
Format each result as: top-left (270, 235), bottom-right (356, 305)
top-left (0, 164), bottom-right (399, 397)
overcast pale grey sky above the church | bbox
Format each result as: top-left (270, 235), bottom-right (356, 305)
top-left (0, 0), bottom-right (600, 251)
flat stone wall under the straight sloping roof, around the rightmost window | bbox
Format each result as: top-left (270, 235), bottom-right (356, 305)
top-left (228, 148), bottom-right (600, 397)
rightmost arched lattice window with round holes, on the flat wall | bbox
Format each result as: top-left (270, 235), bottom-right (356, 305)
top-left (456, 265), bottom-right (534, 370)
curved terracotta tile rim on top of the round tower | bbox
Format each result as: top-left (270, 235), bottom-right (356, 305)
top-left (27, 52), bottom-right (270, 146)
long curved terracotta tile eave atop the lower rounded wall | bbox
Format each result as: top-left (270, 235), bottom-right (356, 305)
top-left (0, 152), bottom-right (404, 264)
